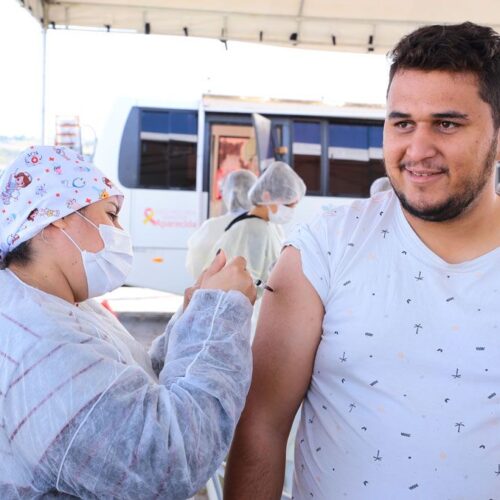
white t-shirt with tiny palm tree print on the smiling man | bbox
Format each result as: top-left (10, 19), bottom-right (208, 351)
top-left (288, 191), bottom-right (500, 500)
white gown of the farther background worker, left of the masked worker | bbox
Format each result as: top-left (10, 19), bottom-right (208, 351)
top-left (186, 211), bottom-right (243, 279)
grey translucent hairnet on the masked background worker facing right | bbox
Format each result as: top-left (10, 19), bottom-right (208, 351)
top-left (248, 161), bottom-right (306, 205)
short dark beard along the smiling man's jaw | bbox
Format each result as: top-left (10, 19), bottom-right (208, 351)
top-left (389, 137), bottom-right (498, 222)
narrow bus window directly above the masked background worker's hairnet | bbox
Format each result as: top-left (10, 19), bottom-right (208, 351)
top-left (292, 121), bottom-right (321, 194)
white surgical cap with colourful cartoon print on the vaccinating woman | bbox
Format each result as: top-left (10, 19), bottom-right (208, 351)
top-left (0, 146), bottom-right (123, 268)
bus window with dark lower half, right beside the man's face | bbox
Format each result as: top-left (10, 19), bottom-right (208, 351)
top-left (328, 123), bottom-right (385, 197)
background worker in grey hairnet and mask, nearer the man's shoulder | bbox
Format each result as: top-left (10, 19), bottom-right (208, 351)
top-left (212, 161), bottom-right (306, 335)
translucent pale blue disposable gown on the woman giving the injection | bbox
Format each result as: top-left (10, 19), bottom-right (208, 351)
top-left (0, 270), bottom-right (252, 500)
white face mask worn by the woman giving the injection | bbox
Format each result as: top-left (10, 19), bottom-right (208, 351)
top-left (62, 212), bottom-right (134, 299)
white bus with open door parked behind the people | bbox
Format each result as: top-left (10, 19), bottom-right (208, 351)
top-left (95, 96), bottom-right (384, 293)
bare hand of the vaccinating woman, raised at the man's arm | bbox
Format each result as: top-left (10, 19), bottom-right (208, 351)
top-left (199, 251), bottom-right (257, 304)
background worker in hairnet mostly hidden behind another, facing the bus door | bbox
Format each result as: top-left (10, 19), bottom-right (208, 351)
top-left (186, 170), bottom-right (257, 279)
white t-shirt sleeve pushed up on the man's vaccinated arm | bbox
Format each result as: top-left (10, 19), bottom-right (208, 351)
top-left (284, 216), bottom-right (331, 305)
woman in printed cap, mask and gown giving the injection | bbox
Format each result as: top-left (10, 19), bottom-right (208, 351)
top-left (0, 146), bottom-right (255, 500)
